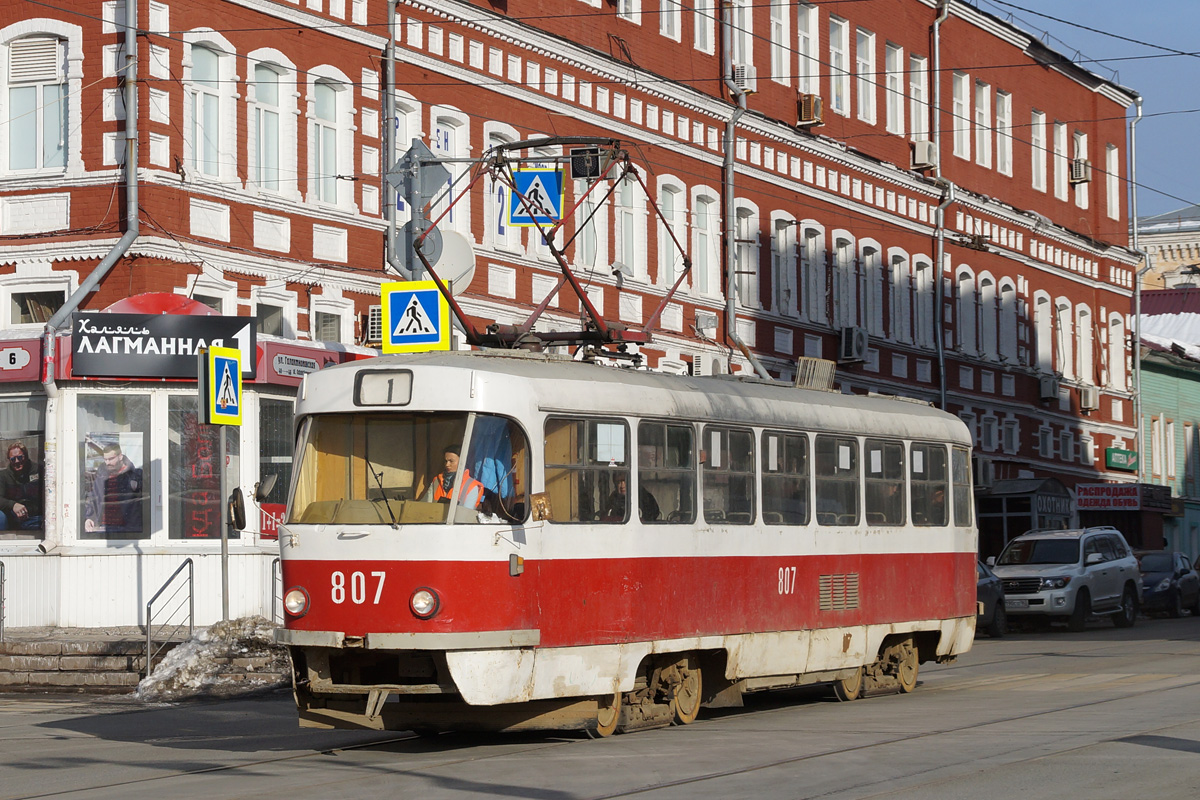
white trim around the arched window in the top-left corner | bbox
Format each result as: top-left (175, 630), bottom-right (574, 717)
top-left (0, 18), bottom-right (86, 179)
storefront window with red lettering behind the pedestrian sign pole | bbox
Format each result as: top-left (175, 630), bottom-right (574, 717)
top-left (167, 395), bottom-right (239, 539)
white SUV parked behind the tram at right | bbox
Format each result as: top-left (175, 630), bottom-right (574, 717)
top-left (988, 527), bottom-right (1141, 631)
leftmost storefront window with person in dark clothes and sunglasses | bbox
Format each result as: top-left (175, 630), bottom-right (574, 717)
top-left (0, 397), bottom-right (46, 539)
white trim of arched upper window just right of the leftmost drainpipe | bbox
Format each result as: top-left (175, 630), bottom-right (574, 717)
top-left (182, 28), bottom-right (245, 190)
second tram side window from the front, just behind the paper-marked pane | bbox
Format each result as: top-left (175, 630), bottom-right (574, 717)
top-left (637, 422), bottom-right (696, 523)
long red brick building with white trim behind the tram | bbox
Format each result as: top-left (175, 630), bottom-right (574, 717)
top-left (0, 0), bottom-right (1138, 624)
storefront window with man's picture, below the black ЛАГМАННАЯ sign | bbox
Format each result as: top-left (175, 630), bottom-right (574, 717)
top-left (78, 392), bottom-right (150, 540)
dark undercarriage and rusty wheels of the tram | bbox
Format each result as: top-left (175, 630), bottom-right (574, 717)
top-left (292, 632), bottom-right (954, 736)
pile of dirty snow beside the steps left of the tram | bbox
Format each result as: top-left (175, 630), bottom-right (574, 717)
top-left (136, 616), bottom-right (292, 702)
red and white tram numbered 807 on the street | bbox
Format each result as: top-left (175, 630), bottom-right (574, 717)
top-left (278, 350), bottom-right (976, 735)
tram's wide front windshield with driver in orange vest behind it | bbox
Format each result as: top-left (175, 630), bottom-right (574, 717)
top-left (287, 411), bottom-right (529, 525)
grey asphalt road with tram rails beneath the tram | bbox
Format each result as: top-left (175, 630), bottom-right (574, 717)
top-left (0, 616), bottom-right (1200, 800)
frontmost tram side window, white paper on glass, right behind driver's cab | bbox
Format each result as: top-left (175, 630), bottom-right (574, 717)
top-left (545, 417), bottom-right (629, 523)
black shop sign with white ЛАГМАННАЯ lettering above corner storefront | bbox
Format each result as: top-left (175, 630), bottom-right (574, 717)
top-left (71, 312), bottom-right (258, 380)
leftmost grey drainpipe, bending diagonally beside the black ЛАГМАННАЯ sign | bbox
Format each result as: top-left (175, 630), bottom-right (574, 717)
top-left (42, 0), bottom-right (139, 549)
